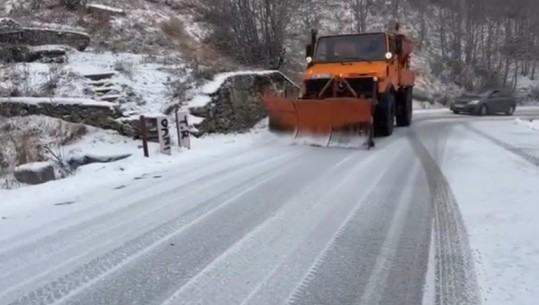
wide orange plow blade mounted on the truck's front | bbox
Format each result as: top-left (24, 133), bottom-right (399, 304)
top-left (264, 96), bottom-right (374, 148)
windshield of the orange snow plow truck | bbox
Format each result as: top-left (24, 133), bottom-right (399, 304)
top-left (314, 33), bottom-right (387, 62)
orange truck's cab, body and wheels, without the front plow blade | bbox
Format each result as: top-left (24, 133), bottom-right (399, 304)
top-left (302, 30), bottom-right (415, 136)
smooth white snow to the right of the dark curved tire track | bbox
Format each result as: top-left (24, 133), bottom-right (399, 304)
top-left (443, 121), bottom-right (539, 305)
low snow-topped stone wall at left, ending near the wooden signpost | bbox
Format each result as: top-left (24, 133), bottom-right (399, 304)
top-left (0, 98), bottom-right (133, 137)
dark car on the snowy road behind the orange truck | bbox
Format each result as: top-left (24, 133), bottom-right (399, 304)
top-left (450, 90), bottom-right (517, 115)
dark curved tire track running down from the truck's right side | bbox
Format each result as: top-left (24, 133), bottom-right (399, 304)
top-left (409, 133), bottom-right (481, 305)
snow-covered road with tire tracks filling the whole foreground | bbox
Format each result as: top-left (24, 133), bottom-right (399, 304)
top-left (0, 109), bottom-right (539, 305)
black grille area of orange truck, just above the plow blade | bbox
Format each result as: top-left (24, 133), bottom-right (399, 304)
top-left (304, 77), bottom-right (374, 98)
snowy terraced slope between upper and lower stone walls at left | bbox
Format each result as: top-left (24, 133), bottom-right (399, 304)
top-left (0, 50), bottom-right (190, 113)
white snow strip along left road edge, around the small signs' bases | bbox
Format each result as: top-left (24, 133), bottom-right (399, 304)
top-left (0, 123), bottom-right (269, 233)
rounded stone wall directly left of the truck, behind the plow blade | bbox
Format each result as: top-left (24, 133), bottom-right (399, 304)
top-left (190, 71), bottom-right (300, 134)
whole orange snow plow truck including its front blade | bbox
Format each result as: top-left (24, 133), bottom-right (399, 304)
top-left (264, 25), bottom-right (415, 148)
